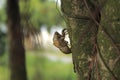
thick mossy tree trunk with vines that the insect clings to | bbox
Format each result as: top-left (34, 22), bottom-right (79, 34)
top-left (61, 0), bottom-right (120, 80)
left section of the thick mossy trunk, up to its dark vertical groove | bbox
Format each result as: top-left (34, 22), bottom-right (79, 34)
top-left (61, 0), bottom-right (100, 80)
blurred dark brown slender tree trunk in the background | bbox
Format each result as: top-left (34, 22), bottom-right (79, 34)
top-left (7, 0), bottom-right (27, 80)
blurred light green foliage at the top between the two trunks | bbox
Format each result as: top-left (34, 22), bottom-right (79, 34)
top-left (20, 0), bottom-right (63, 29)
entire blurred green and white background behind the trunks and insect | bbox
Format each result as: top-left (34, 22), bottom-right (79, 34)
top-left (0, 0), bottom-right (76, 80)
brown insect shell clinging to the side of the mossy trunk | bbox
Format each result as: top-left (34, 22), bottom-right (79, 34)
top-left (53, 29), bottom-right (71, 54)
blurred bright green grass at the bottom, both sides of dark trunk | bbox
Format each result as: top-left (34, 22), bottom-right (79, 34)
top-left (0, 51), bottom-right (76, 80)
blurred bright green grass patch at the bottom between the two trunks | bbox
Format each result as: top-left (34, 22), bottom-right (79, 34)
top-left (27, 52), bottom-right (76, 80)
